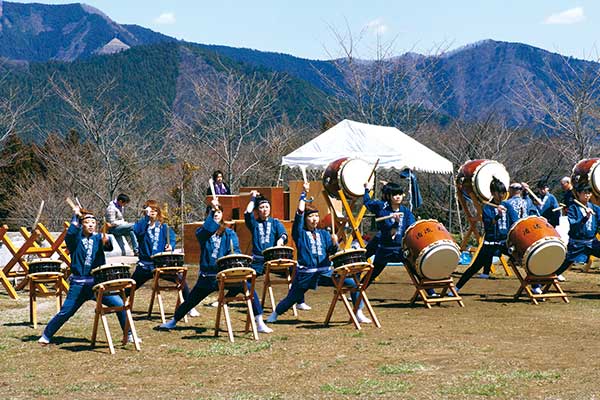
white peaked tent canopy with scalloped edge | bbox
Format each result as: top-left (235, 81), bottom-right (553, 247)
top-left (281, 119), bottom-right (453, 174)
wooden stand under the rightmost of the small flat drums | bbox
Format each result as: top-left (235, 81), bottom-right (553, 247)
top-left (325, 262), bottom-right (381, 330)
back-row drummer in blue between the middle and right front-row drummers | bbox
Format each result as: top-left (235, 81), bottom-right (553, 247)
top-left (244, 190), bottom-right (311, 311)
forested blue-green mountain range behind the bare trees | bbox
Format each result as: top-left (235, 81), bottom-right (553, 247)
top-left (0, 0), bottom-right (598, 138)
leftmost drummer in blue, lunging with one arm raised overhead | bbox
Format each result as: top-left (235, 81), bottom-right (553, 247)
top-left (38, 207), bottom-right (133, 345)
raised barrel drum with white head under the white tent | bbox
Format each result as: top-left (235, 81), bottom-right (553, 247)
top-left (323, 157), bottom-right (375, 198)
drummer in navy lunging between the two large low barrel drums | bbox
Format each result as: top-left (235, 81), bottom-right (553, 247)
top-left (456, 177), bottom-right (518, 290)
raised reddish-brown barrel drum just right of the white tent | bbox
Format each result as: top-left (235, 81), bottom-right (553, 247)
top-left (456, 160), bottom-right (510, 203)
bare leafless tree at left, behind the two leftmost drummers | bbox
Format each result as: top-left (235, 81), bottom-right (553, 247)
top-left (42, 77), bottom-right (164, 203)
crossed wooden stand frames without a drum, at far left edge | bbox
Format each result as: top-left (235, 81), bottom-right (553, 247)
top-left (0, 223), bottom-right (71, 299)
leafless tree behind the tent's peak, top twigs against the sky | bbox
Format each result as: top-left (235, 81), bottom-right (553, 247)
top-left (320, 23), bottom-right (450, 131)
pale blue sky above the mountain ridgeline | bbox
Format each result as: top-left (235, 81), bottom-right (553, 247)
top-left (14, 0), bottom-right (600, 60)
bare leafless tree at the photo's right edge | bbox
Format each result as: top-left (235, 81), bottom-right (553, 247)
top-left (513, 56), bottom-right (600, 165)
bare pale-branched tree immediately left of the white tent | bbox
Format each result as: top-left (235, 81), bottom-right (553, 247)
top-left (172, 65), bottom-right (284, 188)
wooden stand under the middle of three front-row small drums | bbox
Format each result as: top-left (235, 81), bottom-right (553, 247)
top-left (215, 267), bottom-right (258, 343)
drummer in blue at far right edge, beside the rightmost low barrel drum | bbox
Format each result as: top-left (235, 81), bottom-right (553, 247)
top-left (556, 183), bottom-right (600, 276)
